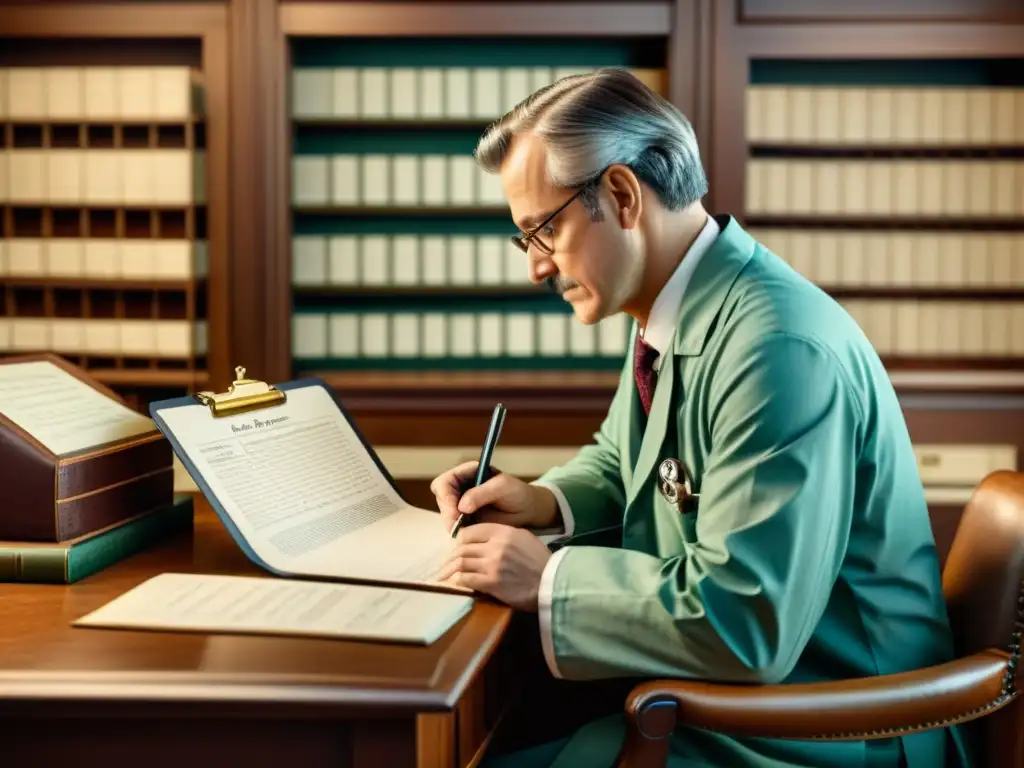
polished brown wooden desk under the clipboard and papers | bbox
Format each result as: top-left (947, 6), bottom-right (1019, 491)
top-left (0, 501), bottom-right (519, 768)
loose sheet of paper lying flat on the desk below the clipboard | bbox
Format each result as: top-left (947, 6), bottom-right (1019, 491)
top-left (74, 573), bottom-right (473, 645)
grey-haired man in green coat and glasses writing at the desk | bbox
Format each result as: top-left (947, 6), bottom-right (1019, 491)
top-left (432, 70), bottom-right (966, 768)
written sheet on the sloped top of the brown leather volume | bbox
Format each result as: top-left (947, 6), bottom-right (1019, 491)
top-left (0, 360), bottom-right (156, 456)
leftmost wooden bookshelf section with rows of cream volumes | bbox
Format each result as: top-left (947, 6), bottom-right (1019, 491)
top-left (0, 3), bottom-right (229, 412)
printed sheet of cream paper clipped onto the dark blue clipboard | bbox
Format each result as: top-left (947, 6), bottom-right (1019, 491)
top-left (160, 386), bottom-right (455, 583)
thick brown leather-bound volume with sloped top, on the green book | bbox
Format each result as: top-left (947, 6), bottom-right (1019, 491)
top-left (0, 354), bottom-right (174, 542)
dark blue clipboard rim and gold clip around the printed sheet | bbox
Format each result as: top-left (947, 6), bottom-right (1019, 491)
top-left (150, 367), bottom-right (448, 593)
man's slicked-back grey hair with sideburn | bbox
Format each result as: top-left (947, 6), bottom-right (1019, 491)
top-left (475, 69), bottom-right (708, 218)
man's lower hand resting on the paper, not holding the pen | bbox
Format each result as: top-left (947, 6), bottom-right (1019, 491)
top-left (438, 524), bottom-right (551, 611)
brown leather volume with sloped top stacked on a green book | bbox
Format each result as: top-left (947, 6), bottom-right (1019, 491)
top-left (0, 354), bottom-right (193, 584)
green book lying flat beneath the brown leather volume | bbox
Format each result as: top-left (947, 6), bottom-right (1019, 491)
top-left (0, 494), bottom-right (193, 584)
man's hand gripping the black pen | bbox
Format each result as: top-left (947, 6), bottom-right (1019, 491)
top-left (430, 461), bottom-right (560, 530)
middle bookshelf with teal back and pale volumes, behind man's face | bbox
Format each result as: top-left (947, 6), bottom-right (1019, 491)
top-left (276, 3), bottom-right (674, 410)
